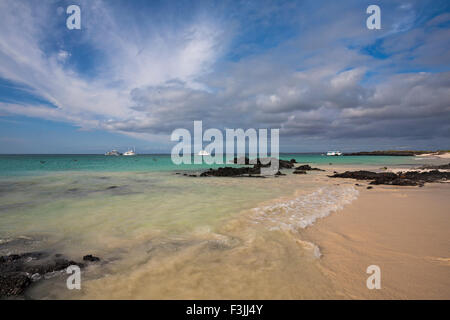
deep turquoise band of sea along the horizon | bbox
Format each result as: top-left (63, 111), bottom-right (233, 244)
top-left (0, 154), bottom-right (420, 176)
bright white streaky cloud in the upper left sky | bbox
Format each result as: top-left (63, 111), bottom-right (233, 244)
top-left (0, 0), bottom-right (224, 136)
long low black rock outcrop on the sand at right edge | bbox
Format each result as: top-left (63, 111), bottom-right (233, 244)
top-left (329, 170), bottom-right (450, 186)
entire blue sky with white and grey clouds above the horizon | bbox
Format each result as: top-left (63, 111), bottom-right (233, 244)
top-left (0, 0), bottom-right (450, 154)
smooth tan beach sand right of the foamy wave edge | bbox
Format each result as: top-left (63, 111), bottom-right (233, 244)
top-left (303, 184), bottom-right (450, 299)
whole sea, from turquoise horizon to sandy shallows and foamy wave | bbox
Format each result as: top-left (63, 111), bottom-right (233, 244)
top-left (0, 154), bottom-right (426, 299)
